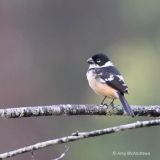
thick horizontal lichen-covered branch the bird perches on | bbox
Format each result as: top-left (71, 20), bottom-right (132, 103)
top-left (0, 104), bottom-right (160, 118)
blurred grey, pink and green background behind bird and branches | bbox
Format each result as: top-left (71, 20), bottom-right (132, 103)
top-left (0, 0), bottom-right (160, 160)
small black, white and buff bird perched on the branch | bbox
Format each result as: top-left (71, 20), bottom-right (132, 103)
top-left (86, 53), bottom-right (135, 117)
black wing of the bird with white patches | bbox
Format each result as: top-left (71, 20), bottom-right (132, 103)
top-left (96, 66), bottom-right (128, 93)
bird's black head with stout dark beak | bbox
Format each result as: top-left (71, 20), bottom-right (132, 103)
top-left (87, 53), bottom-right (110, 66)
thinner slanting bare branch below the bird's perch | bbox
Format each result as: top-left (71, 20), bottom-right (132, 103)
top-left (0, 119), bottom-right (160, 159)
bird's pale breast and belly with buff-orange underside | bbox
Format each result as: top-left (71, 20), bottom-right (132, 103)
top-left (87, 70), bottom-right (119, 99)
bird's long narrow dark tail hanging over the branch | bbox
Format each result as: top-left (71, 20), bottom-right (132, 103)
top-left (118, 92), bottom-right (135, 117)
